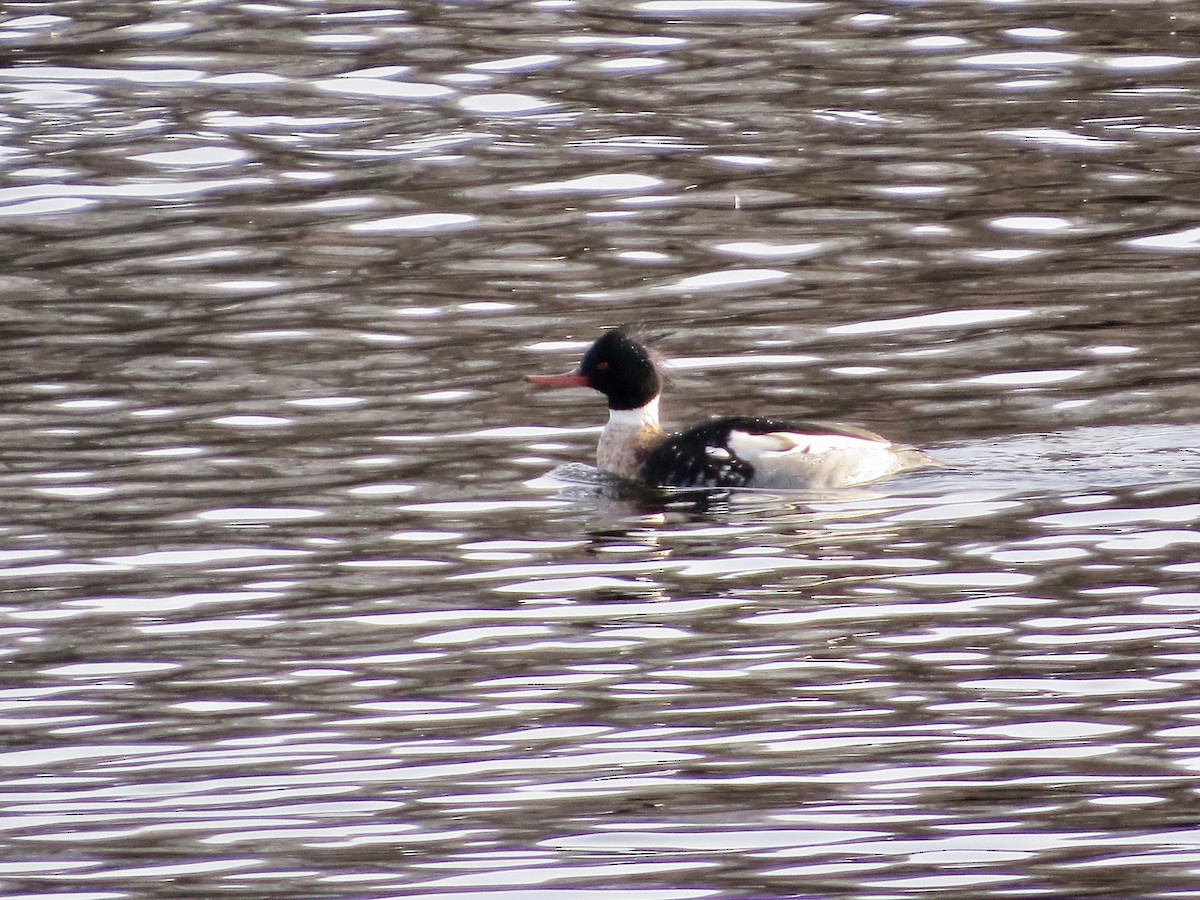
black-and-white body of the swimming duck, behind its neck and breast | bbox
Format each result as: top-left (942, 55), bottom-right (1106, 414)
top-left (642, 416), bottom-right (932, 490)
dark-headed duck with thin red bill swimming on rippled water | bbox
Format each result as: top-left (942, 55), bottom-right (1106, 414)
top-left (526, 325), bottom-right (937, 490)
